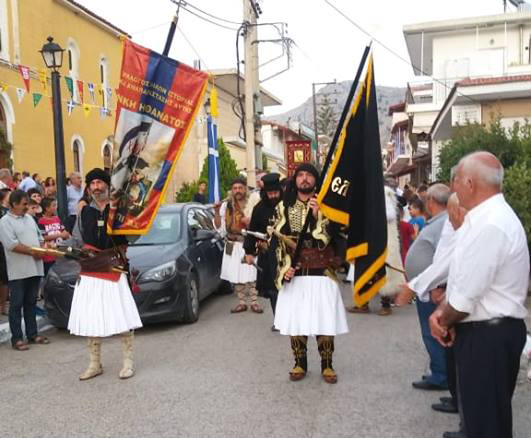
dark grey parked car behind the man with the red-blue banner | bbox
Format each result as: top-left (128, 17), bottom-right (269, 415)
top-left (44, 203), bottom-right (230, 327)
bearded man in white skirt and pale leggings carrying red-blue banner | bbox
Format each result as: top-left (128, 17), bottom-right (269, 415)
top-left (68, 168), bottom-right (142, 380)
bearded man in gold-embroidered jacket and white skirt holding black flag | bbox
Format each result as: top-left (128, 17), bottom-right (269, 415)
top-left (272, 163), bottom-right (348, 383)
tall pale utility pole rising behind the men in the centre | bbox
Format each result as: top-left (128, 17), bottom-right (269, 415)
top-left (243, 0), bottom-right (259, 187)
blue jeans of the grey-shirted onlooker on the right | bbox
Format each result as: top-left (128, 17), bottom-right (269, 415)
top-left (416, 300), bottom-right (447, 387)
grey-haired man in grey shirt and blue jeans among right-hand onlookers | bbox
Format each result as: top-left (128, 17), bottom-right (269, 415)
top-left (405, 184), bottom-right (450, 390)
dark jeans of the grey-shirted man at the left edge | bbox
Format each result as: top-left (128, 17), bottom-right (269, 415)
top-left (8, 277), bottom-right (41, 345)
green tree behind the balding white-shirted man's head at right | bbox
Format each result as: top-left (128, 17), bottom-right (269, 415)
top-left (437, 118), bottom-right (531, 246)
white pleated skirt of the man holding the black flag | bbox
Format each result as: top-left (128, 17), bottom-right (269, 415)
top-left (274, 276), bottom-right (348, 336)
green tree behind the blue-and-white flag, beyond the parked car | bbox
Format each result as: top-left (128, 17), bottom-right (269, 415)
top-left (175, 138), bottom-right (240, 202)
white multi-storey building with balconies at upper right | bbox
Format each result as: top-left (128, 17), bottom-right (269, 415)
top-left (403, 10), bottom-right (531, 179)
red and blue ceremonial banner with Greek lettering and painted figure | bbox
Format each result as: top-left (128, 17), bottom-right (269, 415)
top-left (107, 40), bottom-right (208, 234)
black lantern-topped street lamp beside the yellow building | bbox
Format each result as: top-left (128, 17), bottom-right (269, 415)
top-left (39, 37), bottom-right (68, 223)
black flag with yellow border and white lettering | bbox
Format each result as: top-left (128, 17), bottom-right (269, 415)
top-left (317, 48), bottom-right (387, 306)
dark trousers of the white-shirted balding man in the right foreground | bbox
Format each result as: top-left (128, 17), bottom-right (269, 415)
top-left (455, 318), bottom-right (526, 438)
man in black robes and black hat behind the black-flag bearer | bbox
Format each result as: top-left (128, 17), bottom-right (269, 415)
top-left (243, 173), bottom-right (282, 331)
